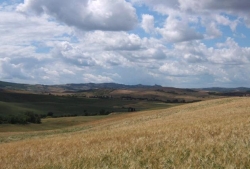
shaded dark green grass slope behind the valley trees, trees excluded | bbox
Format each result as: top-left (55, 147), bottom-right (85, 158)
top-left (0, 92), bottom-right (177, 116)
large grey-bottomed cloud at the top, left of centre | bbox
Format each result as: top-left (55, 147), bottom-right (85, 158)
top-left (17, 0), bottom-right (137, 31)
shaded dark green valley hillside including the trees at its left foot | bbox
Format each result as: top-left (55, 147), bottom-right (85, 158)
top-left (0, 90), bottom-right (177, 125)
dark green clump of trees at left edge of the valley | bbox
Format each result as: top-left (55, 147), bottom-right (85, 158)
top-left (0, 111), bottom-right (41, 124)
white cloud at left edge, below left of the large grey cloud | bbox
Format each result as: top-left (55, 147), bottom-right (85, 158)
top-left (0, 11), bottom-right (72, 45)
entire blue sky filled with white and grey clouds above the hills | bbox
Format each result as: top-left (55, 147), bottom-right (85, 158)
top-left (0, 0), bottom-right (250, 88)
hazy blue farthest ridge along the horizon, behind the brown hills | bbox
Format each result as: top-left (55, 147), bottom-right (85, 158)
top-left (0, 81), bottom-right (250, 93)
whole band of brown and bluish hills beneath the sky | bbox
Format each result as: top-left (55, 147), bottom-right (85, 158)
top-left (0, 81), bottom-right (250, 103)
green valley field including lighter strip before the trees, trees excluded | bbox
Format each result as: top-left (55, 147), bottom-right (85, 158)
top-left (0, 92), bottom-right (177, 128)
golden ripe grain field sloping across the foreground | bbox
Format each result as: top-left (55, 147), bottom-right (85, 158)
top-left (0, 98), bottom-right (250, 168)
